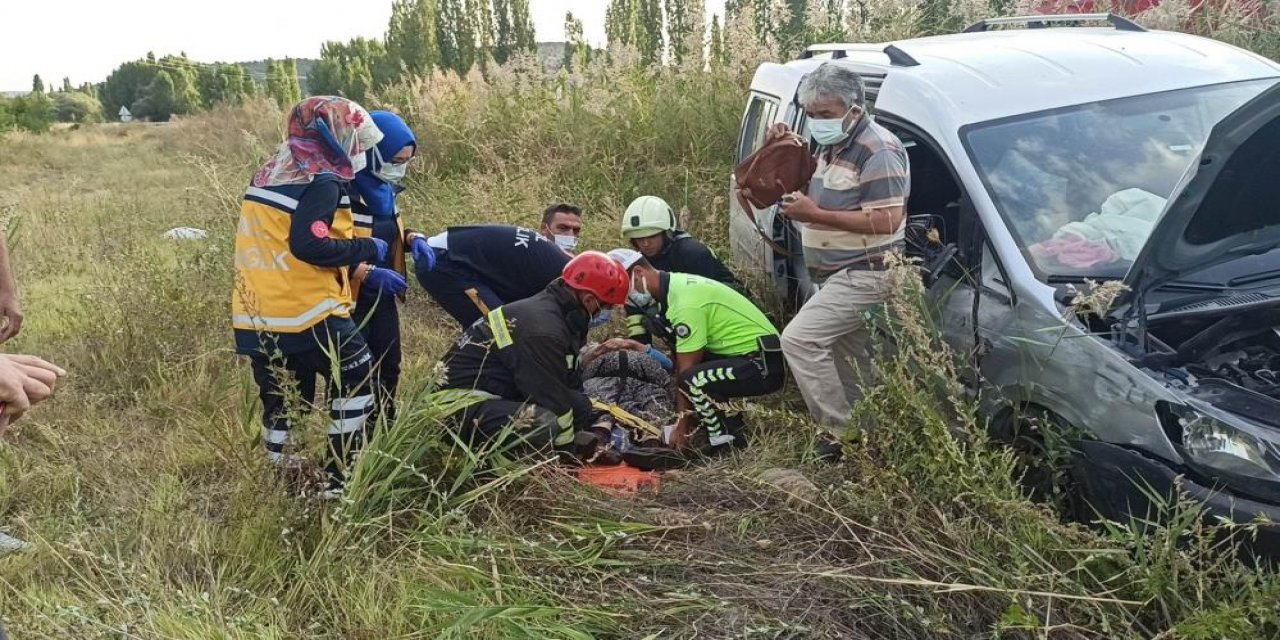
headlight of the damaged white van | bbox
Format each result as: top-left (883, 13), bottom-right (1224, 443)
top-left (1166, 406), bottom-right (1280, 500)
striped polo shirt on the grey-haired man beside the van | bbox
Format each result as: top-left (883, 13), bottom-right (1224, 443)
top-left (800, 116), bottom-right (911, 283)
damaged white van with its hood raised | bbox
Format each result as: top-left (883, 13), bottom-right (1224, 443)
top-left (728, 14), bottom-right (1280, 549)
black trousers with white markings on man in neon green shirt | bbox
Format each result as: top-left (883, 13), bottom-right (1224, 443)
top-left (681, 335), bottom-right (786, 447)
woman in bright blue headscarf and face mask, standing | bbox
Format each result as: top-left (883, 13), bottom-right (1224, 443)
top-left (352, 111), bottom-right (435, 421)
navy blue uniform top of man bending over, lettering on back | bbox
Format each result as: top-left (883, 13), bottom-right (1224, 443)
top-left (417, 224), bottom-right (572, 329)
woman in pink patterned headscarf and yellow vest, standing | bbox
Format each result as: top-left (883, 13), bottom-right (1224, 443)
top-left (232, 96), bottom-right (404, 489)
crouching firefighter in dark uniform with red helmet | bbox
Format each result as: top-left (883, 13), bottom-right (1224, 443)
top-left (442, 251), bottom-right (631, 451)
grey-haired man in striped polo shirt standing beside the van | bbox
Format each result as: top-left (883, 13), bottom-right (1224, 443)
top-left (772, 61), bottom-right (911, 458)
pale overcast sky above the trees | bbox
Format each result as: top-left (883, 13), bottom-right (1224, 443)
top-left (0, 0), bottom-right (723, 91)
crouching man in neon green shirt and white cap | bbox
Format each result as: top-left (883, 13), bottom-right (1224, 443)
top-left (605, 248), bottom-right (785, 454)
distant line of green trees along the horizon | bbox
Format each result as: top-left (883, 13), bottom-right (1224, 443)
top-left (0, 0), bottom-right (1049, 132)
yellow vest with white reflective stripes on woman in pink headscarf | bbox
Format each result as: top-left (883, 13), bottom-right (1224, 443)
top-left (232, 187), bottom-right (355, 333)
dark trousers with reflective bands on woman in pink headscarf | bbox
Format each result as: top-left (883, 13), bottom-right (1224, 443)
top-left (250, 321), bottom-right (376, 485)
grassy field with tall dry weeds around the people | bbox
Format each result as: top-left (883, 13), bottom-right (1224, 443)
top-left (0, 10), bottom-right (1280, 640)
